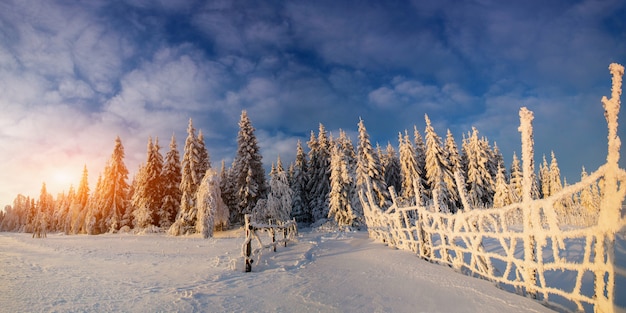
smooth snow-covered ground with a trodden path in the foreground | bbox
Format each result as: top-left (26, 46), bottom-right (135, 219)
top-left (0, 229), bottom-right (572, 313)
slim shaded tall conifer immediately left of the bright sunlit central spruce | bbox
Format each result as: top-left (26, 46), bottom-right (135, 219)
top-left (307, 123), bottom-right (330, 221)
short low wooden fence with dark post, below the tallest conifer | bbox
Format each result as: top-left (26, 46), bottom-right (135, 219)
top-left (242, 214), bottom-right (298, 272)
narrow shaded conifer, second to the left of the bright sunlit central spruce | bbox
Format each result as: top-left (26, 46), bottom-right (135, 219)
top-left (291, 140), bottom-right (313, 223)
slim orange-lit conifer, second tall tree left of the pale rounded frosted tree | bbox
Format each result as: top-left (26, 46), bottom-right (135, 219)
top-left (157, 135), bottom-right (182, 229)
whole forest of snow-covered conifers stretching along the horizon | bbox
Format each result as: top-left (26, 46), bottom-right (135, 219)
top-left (0, 111), bottom-right (600, 237)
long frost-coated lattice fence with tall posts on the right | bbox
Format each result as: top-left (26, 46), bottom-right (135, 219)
top-left (360, 64), bottom-right (626, 312)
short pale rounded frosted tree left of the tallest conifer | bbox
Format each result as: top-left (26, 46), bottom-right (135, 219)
top-left (196, 168), bottom-right (228, 238)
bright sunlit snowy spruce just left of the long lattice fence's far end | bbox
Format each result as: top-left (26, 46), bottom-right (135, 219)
top-left (328, 132), bottom-right (357, 226)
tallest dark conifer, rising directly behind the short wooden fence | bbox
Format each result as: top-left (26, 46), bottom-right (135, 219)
top-left (233, 110), bottom-right (267, 224)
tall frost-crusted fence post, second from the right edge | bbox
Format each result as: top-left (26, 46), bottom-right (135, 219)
top-left (518, 107), bottom-right (541, 299)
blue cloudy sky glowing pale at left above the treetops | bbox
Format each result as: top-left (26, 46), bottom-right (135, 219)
top-left (0, 0), bottom-right (626, 206)
